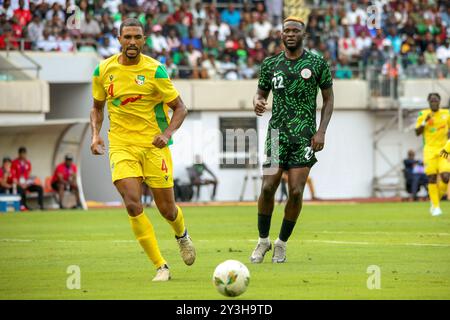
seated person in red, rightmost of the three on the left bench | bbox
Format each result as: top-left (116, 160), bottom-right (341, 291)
top-left (52, 154), bottom-right (82, 209)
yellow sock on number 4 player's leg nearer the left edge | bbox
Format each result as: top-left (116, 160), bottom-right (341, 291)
top-left (129, 212), bottom-right (166, 268)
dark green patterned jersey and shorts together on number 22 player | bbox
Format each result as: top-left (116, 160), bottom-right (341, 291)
top-left (258, 50), bottom-right (333, 170)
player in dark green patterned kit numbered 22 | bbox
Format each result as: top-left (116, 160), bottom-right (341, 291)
top-left (250, 17), bottom-right (334, 263)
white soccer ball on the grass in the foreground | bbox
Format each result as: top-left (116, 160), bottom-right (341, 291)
top-left (213, 260), bottom-right (250, 297)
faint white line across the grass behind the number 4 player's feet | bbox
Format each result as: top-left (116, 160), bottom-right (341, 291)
top-left (0, 238), bottom-right (450, 247)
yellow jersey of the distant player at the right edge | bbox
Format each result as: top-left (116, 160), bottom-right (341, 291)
top-left (416, 109), bottom-right (450, 152)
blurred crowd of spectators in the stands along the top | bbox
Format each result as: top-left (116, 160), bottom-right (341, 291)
top-left (0, 0), bottom-right (450, 80)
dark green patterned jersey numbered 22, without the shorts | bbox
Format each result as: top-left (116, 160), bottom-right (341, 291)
top-left (258, 49), bottom-right (333, 142)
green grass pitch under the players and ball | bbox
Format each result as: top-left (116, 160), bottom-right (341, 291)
top-left (0, 202), bottom-right (450, 300)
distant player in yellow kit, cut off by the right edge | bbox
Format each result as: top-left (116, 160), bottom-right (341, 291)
top-left (416, 92), bottom-right (450, 216)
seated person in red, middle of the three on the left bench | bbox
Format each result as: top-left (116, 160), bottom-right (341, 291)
top-left (11, 147), bottom-right (44, 210)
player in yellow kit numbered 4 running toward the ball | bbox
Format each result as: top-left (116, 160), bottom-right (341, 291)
top-left (91, 19), bottom-right (195, 281)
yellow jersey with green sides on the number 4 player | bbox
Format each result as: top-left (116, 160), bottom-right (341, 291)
top-left (92, 53), bottom-right (179, 147)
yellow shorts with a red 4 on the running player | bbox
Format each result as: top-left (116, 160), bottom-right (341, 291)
top-left (109, 146), bottom-right (173, 188)
